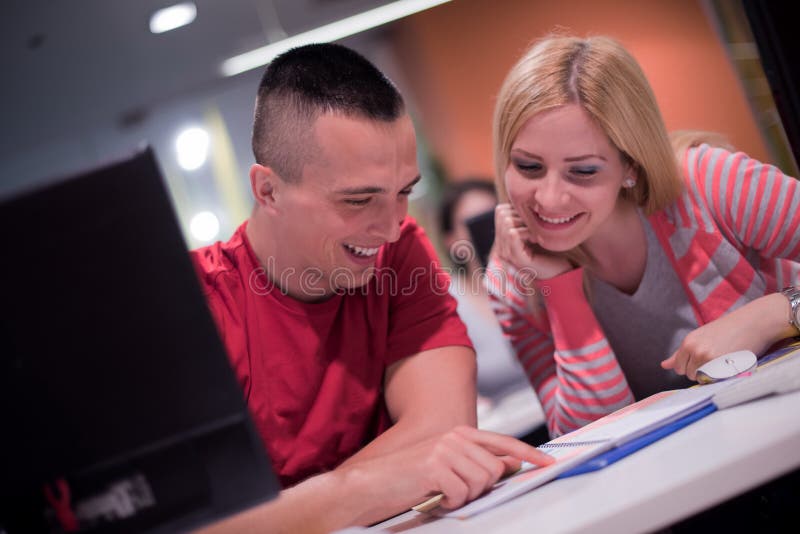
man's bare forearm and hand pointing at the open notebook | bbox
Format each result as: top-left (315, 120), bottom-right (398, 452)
top-left (200, 426), bottom-right (553, 534)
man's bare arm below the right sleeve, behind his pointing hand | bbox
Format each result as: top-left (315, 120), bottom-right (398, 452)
top-left (344, 346), bottom-right (477, 465)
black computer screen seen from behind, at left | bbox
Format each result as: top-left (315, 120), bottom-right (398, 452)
top-left (0, 149), bottom-right (279, 534)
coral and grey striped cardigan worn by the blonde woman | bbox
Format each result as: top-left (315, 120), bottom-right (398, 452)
top-left (487, 145), bottom-right (800, 437)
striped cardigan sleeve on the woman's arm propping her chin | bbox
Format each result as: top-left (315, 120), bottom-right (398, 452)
top-left (487, 257), bottom-right (633, 437)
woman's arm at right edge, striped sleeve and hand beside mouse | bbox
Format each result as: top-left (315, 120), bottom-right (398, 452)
top-left (662, 145), bottom-right (800, 379)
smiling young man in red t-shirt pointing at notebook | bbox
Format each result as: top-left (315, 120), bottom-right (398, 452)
top-left (193, 45), bottom-right (547, 529)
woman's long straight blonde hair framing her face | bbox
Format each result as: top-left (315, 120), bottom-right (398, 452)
top-left (493, 35), bottom-right (684, 215)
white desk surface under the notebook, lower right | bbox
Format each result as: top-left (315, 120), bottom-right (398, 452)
top-left (371, 391), bottom-right (800, 534)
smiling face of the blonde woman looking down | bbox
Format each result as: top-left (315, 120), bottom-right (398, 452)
top-left (504, 104), bottom-right (636, 252)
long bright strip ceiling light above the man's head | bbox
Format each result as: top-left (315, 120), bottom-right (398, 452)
top-left (221, 0), bottom-right (450, 76)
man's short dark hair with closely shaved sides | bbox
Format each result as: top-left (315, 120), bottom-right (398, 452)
top-left (252, 43), bottom-right (405, 181)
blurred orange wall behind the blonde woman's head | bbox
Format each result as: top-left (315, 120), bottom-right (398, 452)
top-left (393, 0), bottom-right (771, 182)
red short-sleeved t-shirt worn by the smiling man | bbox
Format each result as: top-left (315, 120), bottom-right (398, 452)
top-left (192, 217), bottom-right (471, 486)
